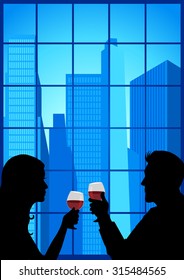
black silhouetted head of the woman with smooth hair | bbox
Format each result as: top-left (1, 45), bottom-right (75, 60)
top-left (1, 154), bottom-right (47, 202)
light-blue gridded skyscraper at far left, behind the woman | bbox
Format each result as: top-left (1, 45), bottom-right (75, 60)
top-left (4, 36), bottom-right (48, 244)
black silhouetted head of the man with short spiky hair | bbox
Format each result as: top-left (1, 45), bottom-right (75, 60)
top-left (141, 151), bottom-right (184, 203)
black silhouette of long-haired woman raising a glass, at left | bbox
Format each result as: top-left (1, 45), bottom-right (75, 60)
top-left (0, 155), bottom-right (79, 260)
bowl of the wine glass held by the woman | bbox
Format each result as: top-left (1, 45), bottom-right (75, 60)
top-left (67, 191), bottom-right (84, 210)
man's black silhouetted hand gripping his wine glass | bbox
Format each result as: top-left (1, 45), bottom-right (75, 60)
top-left (89, 192), bottom-right (109, 222)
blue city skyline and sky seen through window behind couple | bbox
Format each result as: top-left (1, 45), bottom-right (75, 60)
top-left (3, 4), bottom-right (181, 258)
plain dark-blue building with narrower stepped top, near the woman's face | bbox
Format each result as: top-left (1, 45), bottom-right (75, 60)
top-left (47, 114), bottom-right (80, 255)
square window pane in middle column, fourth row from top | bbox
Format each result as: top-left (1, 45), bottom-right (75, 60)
top-left (74, 129), bottom-right (108, 170)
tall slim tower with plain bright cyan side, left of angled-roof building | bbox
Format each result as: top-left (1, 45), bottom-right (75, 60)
top-left (101, 38), bottom-right (130, 236)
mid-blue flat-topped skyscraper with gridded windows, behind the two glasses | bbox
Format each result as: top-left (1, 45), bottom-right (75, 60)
top-left (66, 74), bottom-right (108, 254)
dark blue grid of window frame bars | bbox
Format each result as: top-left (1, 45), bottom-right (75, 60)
top-left (0, 0), bottom-right (184, 255)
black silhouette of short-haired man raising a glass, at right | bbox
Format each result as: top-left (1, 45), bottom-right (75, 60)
top-left (89, 151), bottom-right (184, 260)
